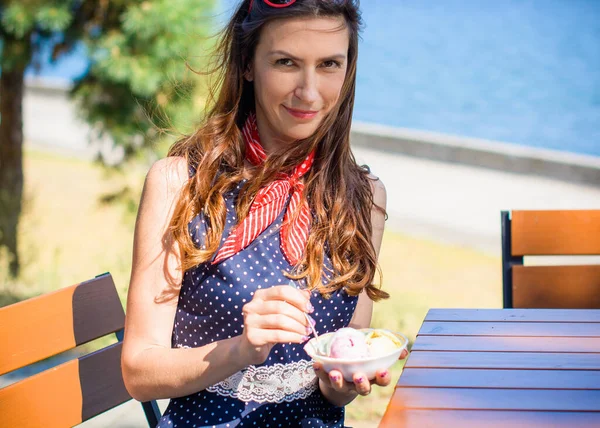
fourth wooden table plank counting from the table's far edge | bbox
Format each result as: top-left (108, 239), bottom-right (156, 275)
top-left (405, 351), bottom-right (600, 370)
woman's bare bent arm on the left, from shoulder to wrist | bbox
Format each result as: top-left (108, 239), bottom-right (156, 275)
top-left (122, 158), bottom-right (246, 401)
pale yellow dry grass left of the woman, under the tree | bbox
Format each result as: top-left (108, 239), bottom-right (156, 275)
top-left (0, 151), bottom-right (144, 306)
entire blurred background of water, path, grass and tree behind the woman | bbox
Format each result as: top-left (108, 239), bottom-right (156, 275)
top-left (0, 0), bottom-right (600, 427)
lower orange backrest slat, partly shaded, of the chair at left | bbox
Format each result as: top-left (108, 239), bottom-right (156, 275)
top-left (0, 342), bottom-right (131, 428)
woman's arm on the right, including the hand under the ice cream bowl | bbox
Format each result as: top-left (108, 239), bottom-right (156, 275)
top-left (315, 177), bottom-right (390, 406)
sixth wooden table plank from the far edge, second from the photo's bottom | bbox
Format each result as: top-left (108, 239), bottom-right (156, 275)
top-left (392, 388), bottom-right (600, 412)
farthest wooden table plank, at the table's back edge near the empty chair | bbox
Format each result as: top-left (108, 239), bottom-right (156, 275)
top-left (425, 309), bottom-right (600, 323)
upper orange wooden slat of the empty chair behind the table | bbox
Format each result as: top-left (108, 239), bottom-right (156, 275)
top-left (511, 210), bottom-right (600, 256)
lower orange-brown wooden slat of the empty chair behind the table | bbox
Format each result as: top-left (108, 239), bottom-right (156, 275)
top-left (512, 265), bottom-right (600, 309)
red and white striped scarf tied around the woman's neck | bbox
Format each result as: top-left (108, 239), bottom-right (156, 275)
top-left (212, 113), bottom-right (315, 266)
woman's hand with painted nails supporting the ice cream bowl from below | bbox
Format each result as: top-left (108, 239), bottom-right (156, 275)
top-left (313, 350), bottom-right (408, 406)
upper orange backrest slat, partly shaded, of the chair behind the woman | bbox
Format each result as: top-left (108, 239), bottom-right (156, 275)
top-left (0, 275), bottom-right (125, 375)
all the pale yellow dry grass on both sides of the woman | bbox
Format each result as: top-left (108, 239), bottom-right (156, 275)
top-left (0, 150), bottom-right (501, 428)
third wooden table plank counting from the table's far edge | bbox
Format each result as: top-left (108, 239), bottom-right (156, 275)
top-left (412, 335), bottom-right (600, 352)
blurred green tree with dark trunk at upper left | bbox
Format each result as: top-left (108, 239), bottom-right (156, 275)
top-left (0, 0), bottom-right (216, 277)
